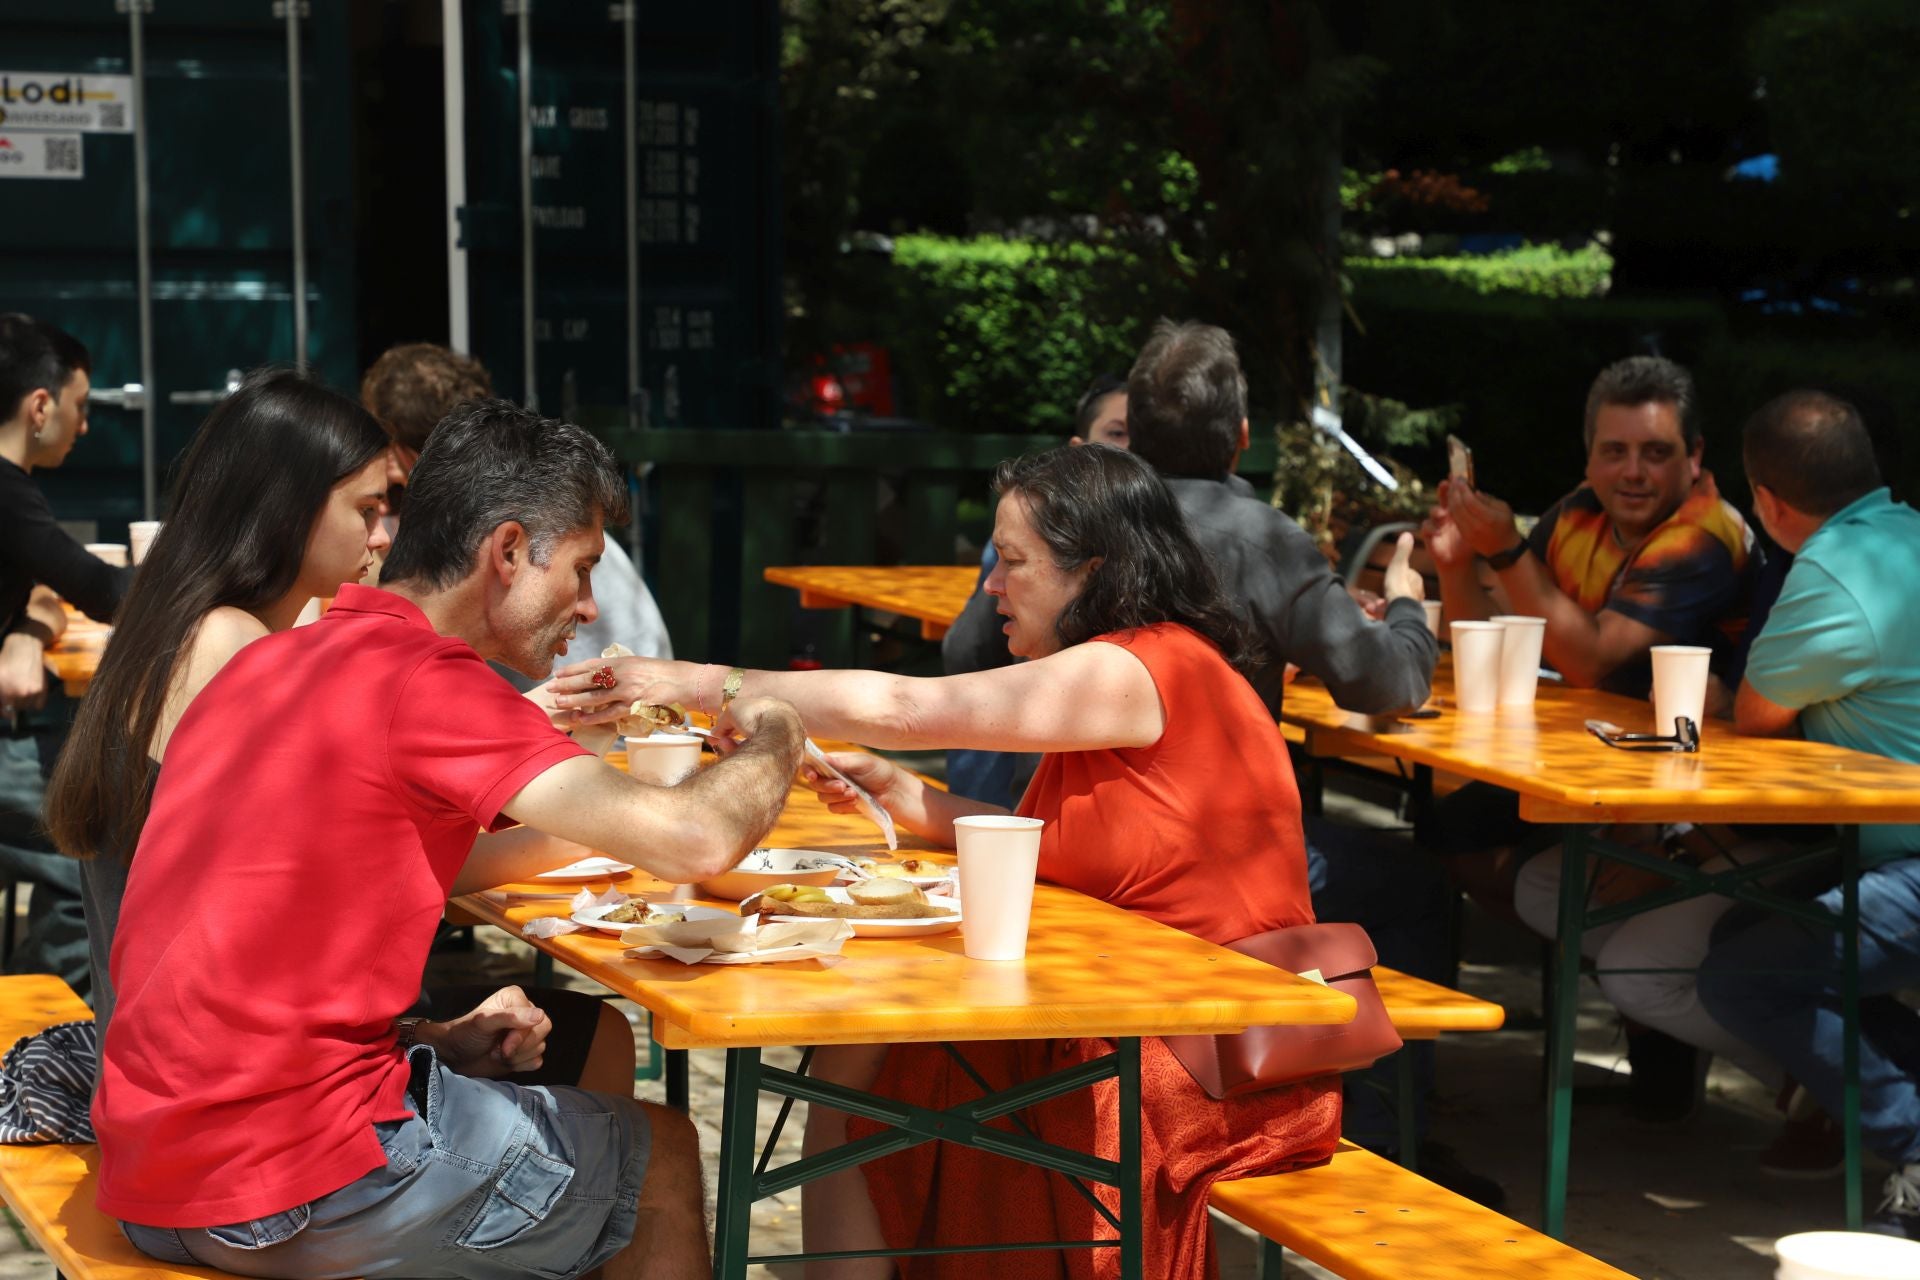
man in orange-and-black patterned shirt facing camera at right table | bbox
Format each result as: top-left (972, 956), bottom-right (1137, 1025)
top-left (1423, 355), bottom-right (1751, 1121)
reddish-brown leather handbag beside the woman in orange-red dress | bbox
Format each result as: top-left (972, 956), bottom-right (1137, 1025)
top-left (1165, 925), bottom-right (1402, 1098)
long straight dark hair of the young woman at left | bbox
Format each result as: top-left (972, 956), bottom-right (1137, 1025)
top-left (46, 368), bottom-right (386, 860)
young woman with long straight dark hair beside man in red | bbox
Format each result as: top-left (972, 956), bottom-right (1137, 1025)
top-left (46, 370), bottom-right (388, 1025)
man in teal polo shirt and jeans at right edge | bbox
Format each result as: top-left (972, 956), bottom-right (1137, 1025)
top-left (1699, 391), bottom-right (1920, 1238)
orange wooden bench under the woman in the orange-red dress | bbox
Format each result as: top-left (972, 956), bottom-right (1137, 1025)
top-left (1208, 1142), bottom-right (1632, 1280)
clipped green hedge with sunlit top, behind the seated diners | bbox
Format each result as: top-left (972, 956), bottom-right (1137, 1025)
top-left (868, 236), bottom-right (1920, 510)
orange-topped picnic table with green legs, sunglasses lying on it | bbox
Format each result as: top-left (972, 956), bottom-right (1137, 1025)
top-left (1281, 660), bottom-right (1920, 1236)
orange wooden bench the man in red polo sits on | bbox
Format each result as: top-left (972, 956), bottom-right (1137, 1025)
top-left (0, 975), bottom-right (230, 1280)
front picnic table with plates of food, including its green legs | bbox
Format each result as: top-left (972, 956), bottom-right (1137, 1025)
top-left (457, 771), bottom-right (1354, 1280)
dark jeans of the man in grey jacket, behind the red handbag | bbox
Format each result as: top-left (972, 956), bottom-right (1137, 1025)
top-left (1306, 818), bottom-right (1452, 1153)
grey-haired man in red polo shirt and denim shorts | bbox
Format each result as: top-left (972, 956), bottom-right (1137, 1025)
top-left (94, 401), bottom-right (803, 1280)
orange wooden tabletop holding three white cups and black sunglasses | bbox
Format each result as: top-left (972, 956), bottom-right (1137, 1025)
top-left (1281, 662), bottom-right (1920, 823)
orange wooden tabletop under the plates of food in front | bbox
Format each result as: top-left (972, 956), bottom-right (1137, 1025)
top-left (457, 771), bottom-right (1354, 1048)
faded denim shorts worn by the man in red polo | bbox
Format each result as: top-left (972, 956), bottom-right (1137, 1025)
top-left (123, 1046), bottom-right (651, 1280)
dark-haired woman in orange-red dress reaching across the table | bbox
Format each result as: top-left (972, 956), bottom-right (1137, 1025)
top-left (553, 445), bottom-right (1340, 1280)
